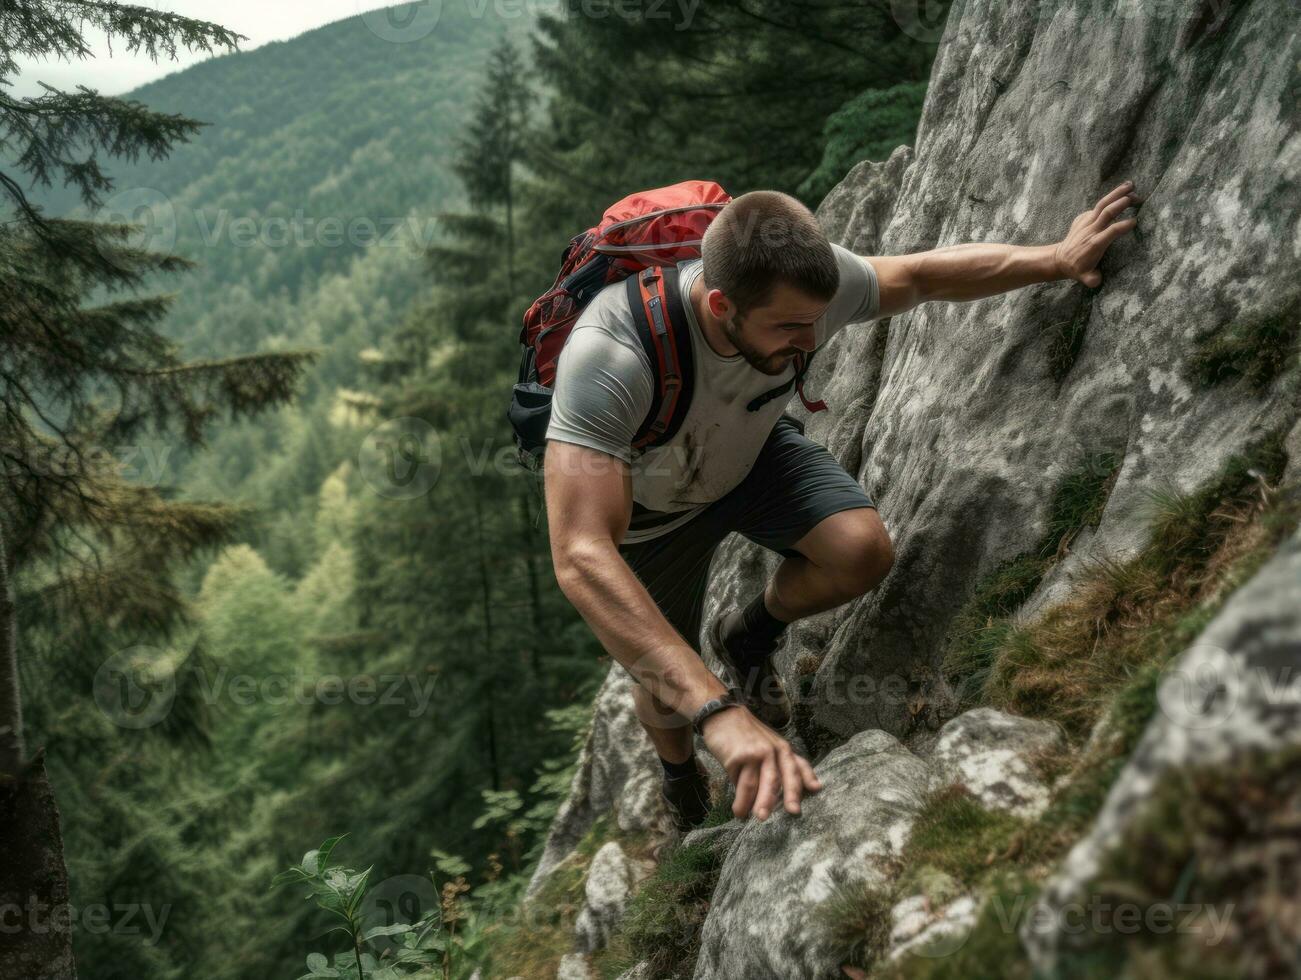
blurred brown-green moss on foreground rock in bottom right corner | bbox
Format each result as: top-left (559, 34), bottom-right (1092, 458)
top-left (1081, 747), bottom-right (1301, 977)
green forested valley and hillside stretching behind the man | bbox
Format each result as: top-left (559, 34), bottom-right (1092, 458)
top-left (5, 3), bottom-right (934, 977)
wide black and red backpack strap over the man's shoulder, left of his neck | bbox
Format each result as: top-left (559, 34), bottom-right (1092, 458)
top-left (624, 265), bottom-right (696, 449)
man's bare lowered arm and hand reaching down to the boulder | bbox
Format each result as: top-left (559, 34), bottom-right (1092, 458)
top-left (544, 440), bottom-right (822, 820)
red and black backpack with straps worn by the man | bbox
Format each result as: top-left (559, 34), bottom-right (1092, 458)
top-left (506, 181), bottom-right (825, 467)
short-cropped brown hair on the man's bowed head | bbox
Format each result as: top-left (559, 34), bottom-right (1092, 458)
top-left (700, 190), bottom-right (840, 314)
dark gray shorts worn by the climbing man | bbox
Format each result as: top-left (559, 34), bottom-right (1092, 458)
top-left (619, 415), bottom-right (876, 658)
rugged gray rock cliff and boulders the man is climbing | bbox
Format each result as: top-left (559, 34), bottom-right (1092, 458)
top-left (528, 0), bottom-right (1301, 977)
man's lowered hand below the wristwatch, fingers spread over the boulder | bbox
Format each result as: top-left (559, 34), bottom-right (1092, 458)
top-left (700, 705), bottom-right (822, 820)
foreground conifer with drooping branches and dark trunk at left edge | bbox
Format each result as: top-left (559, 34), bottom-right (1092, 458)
top-left (0, 0), bottom-right (312, 977)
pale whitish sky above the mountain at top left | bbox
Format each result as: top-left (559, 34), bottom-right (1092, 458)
top-left (4, 0), bottom-right (393, 98)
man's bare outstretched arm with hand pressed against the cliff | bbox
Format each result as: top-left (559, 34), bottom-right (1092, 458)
top-left (864, 181), bottom-right (1141, 316)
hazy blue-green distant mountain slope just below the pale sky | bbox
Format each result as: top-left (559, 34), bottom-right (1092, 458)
top-left (22, 4), bottom-right (532, 364)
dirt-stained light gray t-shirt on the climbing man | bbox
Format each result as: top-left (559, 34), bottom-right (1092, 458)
top-left (546, 245), bottom-right (881, 544)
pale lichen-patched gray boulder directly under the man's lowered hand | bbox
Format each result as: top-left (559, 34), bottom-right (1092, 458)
top-left (695, 731), bottom-right (930, 980)
